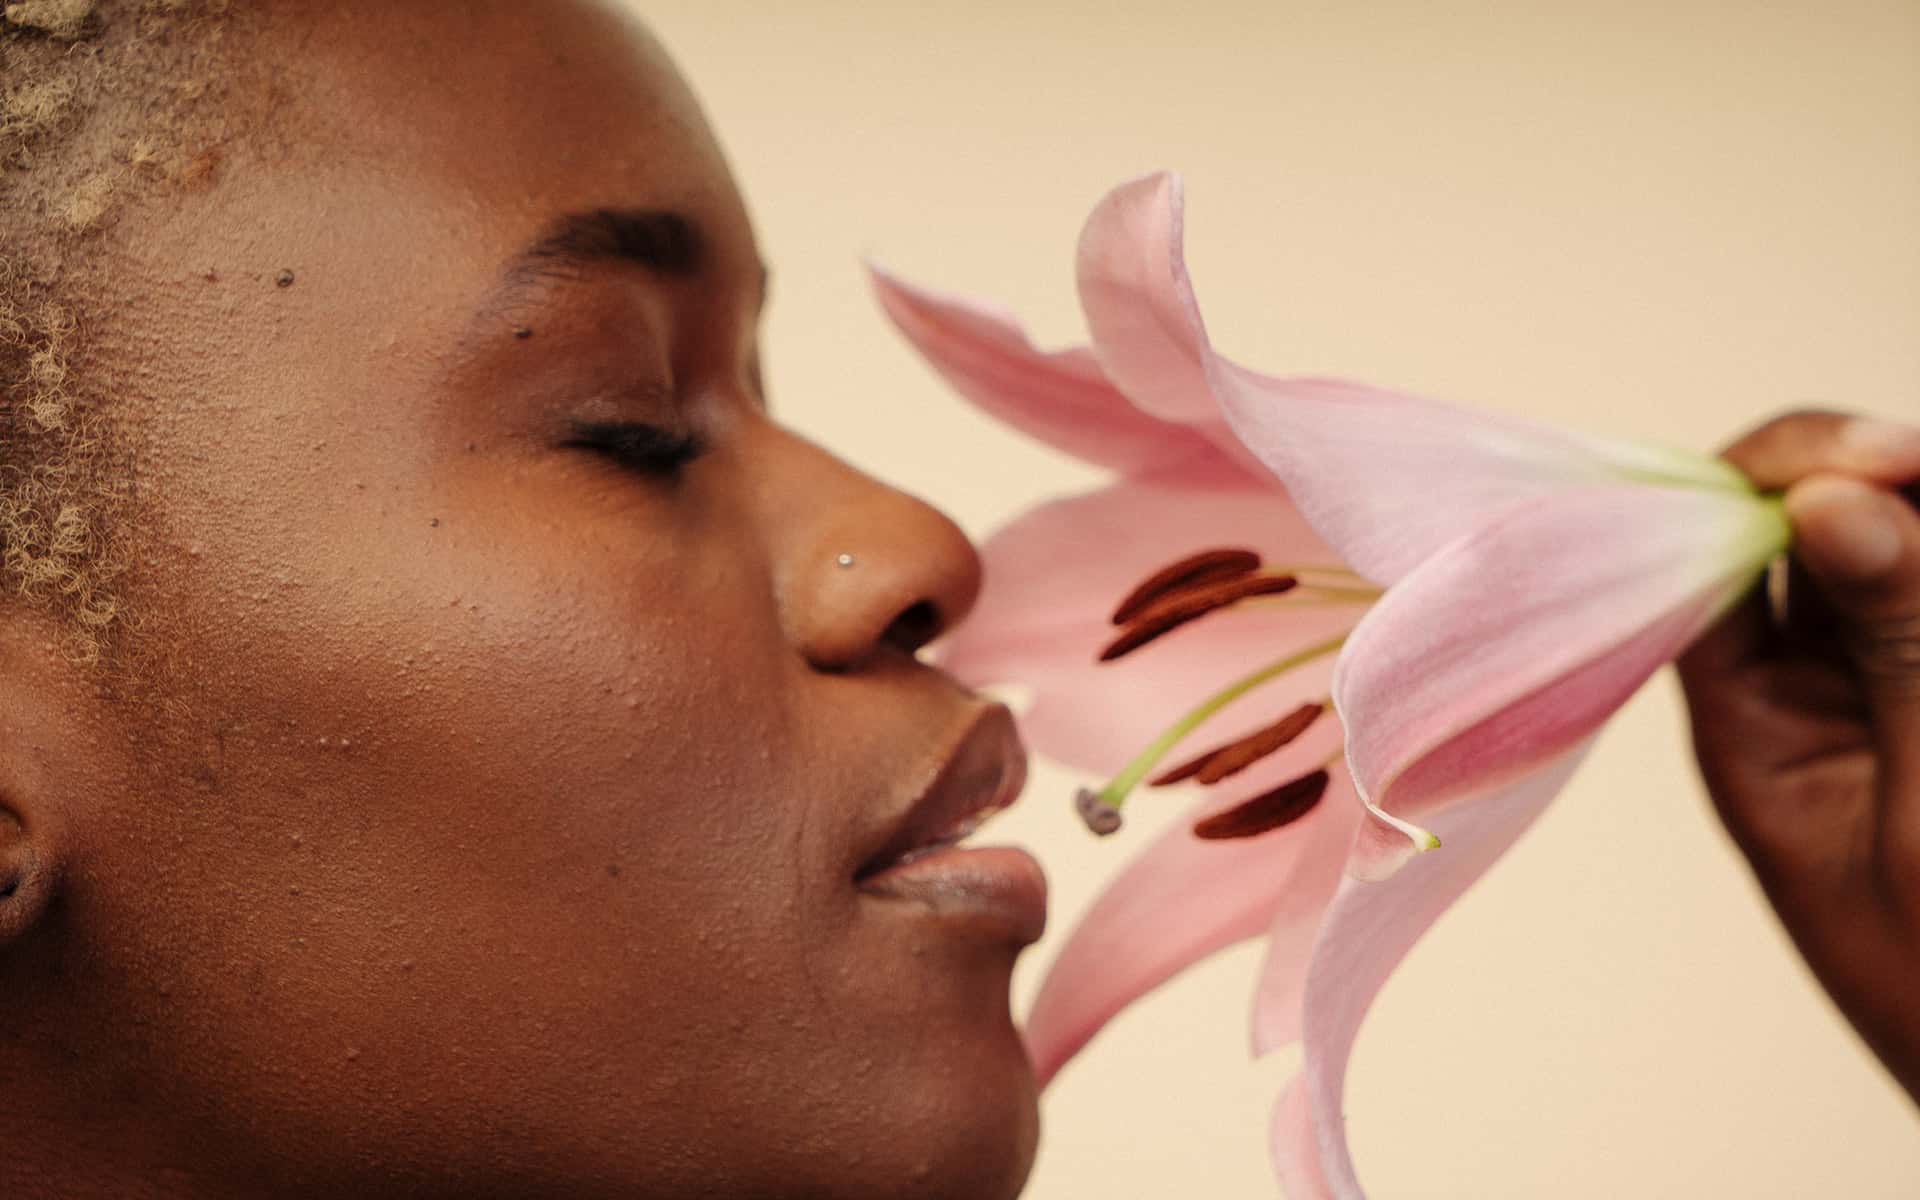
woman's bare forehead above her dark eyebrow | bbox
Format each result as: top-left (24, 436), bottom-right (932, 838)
top-left (257, 0), bottom-right (753, 276)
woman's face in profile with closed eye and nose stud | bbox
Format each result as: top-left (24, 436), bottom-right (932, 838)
top-left (13, 0), bottom-right (1041, 1196)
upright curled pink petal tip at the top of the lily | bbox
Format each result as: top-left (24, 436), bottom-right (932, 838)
top-left (1079, 171), bottom-right (1219, 424)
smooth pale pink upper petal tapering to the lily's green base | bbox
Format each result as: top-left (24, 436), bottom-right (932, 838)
top-left (1208, 355), bottom-right (1749, 584)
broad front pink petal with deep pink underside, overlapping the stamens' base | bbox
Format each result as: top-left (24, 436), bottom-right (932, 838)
top-left (1334, 486), bottom-right (1786, 876)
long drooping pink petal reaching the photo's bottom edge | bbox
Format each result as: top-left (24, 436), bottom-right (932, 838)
top-left (1256, 743), bottom-right (1588, 1200)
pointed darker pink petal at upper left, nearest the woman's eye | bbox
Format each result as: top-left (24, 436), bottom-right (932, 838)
top-left (870, 267), bottom-right (1219, 474)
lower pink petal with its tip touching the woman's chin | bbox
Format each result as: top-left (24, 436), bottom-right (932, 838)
top-left (1027, 744), bottom-right (1365, 1083)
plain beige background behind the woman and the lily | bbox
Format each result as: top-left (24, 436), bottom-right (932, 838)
top-left (643, 0), bottom-right (1920, 1200)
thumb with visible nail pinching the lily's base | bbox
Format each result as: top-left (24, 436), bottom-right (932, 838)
top-left (1786, 474), bottom-right (1920, 756)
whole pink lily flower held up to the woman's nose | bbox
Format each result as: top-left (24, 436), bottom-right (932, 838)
top-left (881, 175), bottom-right (1789, 1198)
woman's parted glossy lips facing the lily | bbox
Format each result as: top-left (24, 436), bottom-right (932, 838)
top-left (854, 705), bottom-right (1046, 945)
